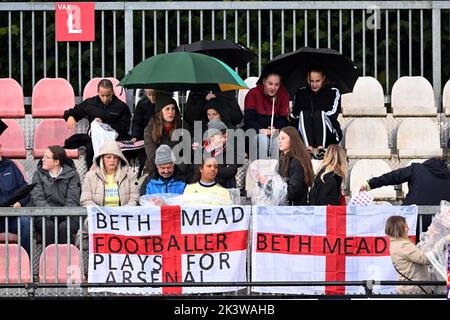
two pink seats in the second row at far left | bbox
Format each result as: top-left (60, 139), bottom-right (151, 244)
top-left (0, 119), bottom-right (78, 159)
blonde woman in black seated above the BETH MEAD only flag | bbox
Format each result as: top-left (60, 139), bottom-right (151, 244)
top-left (309, 144), bottom-right (348, 206)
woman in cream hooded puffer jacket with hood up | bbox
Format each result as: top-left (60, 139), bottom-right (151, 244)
top-left (81, 141), bottom-right (139, 207)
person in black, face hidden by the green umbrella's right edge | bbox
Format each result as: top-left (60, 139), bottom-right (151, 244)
top-left (184, 91), bottom-right (242, 128)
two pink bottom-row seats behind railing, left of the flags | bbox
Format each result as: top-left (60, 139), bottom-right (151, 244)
top-left (0, 243), bottom-right (85, 283)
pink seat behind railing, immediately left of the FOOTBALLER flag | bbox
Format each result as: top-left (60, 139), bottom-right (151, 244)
top-left (39, 244), bottom-right (84, 283)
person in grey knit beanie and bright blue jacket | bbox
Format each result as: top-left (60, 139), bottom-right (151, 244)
top-left (141, 144), bottom-right (186, 195)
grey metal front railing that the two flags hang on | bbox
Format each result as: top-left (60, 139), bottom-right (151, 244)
top-left (0, 206), bottom-right (445, 298)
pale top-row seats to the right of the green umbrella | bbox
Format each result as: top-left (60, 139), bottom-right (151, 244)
top-left (238, 76), bottom-right (450, 117)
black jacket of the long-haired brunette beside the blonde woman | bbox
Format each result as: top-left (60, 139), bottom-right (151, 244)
top-left (278, 158), bottom-right (308, 206)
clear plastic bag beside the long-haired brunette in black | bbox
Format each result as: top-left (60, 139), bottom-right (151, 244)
top-left (247, 162), bottom-right (287, 206)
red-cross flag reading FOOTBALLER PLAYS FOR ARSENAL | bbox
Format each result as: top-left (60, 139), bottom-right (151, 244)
top-left (88, 206), bottom-right (251, 294)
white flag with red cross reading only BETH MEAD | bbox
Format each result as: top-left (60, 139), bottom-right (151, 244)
top-left (252, 206), bottom-right (417, 294)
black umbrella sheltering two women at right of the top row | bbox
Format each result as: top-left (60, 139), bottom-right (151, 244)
top-left (258, 48), bottom-right (359, 96)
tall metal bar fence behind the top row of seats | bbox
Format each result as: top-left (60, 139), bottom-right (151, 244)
top-left (0, 1), bottom-right (450, 109)
